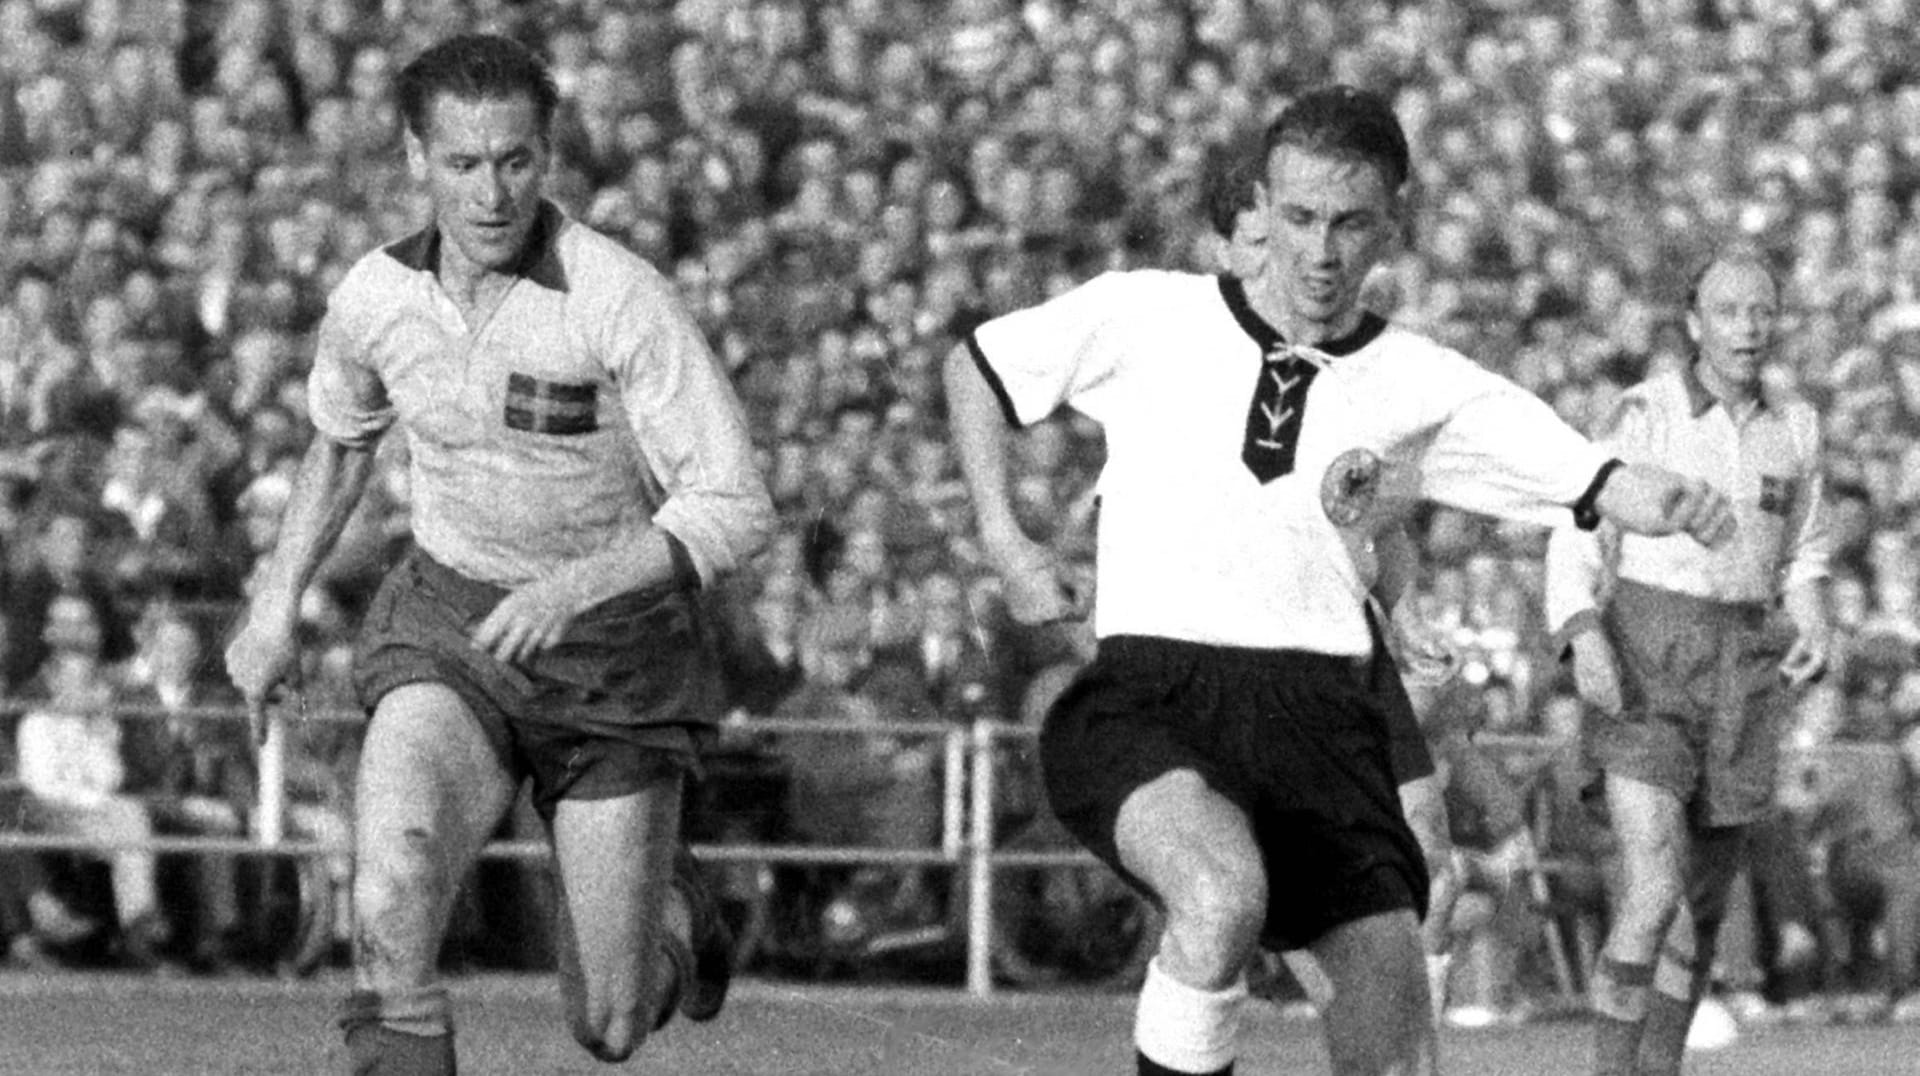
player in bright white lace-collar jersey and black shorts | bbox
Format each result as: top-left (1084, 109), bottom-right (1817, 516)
top-left (947, 86), bottom-right (1732, 1074)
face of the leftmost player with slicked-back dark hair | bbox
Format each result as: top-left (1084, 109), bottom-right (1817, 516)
top-left (407, 92), bottom-right (547, 273)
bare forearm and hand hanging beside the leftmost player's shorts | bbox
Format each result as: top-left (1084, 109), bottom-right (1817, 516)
top-left (227, 436), bottom-right (372, 742)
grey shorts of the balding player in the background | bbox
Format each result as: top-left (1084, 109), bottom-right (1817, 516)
top-left (1586, 580), bottom-right (1793, 826)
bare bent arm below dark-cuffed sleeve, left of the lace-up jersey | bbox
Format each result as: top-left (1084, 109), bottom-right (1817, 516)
top-left (943, 344), bottom-right (1087, 624)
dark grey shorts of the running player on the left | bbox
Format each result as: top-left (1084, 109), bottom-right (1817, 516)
top-left (353, 550), bottom-right (722, 819)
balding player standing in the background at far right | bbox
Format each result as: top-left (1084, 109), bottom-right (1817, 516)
top-left (1548, 252), bottom-right (1832, 1076)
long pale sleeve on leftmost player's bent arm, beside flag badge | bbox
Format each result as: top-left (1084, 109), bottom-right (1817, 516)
top-left (603, 271), bottom-right (774, 584)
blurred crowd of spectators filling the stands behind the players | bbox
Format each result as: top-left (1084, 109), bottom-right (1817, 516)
top-left (0, 0), bottom-right (1920, 1011)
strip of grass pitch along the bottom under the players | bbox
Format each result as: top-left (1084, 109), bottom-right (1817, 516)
top-left (0, 974), bottom-right (1920, 1076)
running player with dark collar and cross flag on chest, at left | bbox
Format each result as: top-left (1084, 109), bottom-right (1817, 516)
top-left (227, 35), bottom-right (772, 1076)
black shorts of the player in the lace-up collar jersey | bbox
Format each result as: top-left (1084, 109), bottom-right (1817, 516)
top-left (1041, 636), bottom-right (1427, 949)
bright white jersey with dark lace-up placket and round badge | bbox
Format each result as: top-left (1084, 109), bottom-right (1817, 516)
top-left (970, 271), bottom-right (1607, 655)
